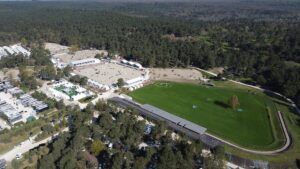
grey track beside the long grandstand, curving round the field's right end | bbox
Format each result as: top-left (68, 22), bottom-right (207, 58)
top-left (111, 97), bottom-right (291, 155)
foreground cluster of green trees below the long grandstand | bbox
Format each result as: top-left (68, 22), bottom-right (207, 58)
top-left (21, 100), bottom-right (224, 169)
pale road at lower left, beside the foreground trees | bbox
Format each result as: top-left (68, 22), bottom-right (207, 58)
top-left (0, 128), bottom-right (69, 161)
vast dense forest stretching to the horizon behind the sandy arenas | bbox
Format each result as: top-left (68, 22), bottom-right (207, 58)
top-left (0, 1), bottom-right (300, 105)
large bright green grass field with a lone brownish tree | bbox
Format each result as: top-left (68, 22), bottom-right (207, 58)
top-left (129, 82), bottom-right (284, 150)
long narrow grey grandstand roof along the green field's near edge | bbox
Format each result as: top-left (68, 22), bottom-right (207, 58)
top-left (141, 104), bottom-right (206, 134)
